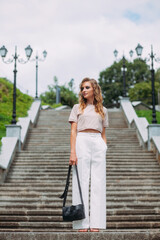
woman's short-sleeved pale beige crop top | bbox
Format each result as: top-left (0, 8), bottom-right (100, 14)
top-left (68, 104), bottom-right (109, 133)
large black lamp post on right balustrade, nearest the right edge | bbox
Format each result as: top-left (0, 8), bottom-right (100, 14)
top-left (135, 44), bottom-right (160, 123)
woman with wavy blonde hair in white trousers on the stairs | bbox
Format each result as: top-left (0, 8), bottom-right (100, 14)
top-left (68, 78), bottom-right (108, 232)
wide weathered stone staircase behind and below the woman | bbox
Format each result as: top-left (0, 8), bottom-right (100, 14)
top-left (0, 109), bottom-right (160, 240)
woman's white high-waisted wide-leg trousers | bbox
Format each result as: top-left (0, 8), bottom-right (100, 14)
top-left (72, 132), bottom-right (107, 229)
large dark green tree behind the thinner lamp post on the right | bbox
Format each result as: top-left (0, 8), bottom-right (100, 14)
top-left (98, 59), bottom-right (150, 106)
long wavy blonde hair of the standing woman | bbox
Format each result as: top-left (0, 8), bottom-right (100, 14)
top-left (78, 78), bottom-right (104, 119)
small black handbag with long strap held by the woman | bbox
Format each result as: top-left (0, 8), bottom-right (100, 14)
top-left (60, 165), bottom-right (85, 222)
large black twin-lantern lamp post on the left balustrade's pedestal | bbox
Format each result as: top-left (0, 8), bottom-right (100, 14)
top-left (0, 45), bottom-right (33, 124)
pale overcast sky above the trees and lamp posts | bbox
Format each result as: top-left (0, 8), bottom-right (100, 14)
top-left (0, 0), bottom-right (160, 96)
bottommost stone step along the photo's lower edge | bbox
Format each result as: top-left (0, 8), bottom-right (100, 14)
top-left (0, 232), bottom-right (160, 240)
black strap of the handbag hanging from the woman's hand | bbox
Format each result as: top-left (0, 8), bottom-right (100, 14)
top-left (60, 165), bottom-right (84, 207)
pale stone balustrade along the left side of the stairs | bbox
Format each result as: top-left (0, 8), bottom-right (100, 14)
top-left (0, 100), bottom-right (41, 182)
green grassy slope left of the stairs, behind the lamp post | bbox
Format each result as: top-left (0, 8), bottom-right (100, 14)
top-left (0, 78), bottom-right (33, 143)
